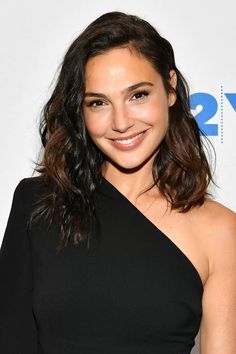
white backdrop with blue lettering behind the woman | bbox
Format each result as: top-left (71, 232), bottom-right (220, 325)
top-left (0, 0), bottom-right (236, 353)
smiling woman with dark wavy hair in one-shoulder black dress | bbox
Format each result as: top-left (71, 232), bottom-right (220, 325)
top-left (0, 12), bottom-right (236, 354)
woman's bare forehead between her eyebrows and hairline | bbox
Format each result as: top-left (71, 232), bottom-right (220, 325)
top-left (85, 48), bottom-right (160, 87)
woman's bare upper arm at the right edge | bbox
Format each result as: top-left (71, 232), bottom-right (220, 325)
top-left (201, 209), bottom-right (236, 354)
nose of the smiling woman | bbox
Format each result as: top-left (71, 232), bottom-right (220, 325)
top-left (112, 106), bottom-right (134, 133)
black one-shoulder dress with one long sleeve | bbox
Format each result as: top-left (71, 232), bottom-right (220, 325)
top-left (0, 178), bottom-right (203, 354)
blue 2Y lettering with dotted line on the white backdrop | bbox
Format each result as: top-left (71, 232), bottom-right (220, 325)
top-left (190, 86), bottom-right (236, 142)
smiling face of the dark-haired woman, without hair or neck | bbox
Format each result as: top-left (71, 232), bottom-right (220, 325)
top-left (83, 48), bottom-right (175, 170)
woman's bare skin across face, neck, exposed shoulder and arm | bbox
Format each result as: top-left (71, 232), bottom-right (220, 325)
top-left (83, 48), bottom-right (236, 354)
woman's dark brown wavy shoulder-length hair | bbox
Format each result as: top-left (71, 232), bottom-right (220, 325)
top-left (34, 12), bottom-right (212, 248)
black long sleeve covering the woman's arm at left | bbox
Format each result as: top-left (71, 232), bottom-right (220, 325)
top-left (0, 179), bottom-right (37, 354)
